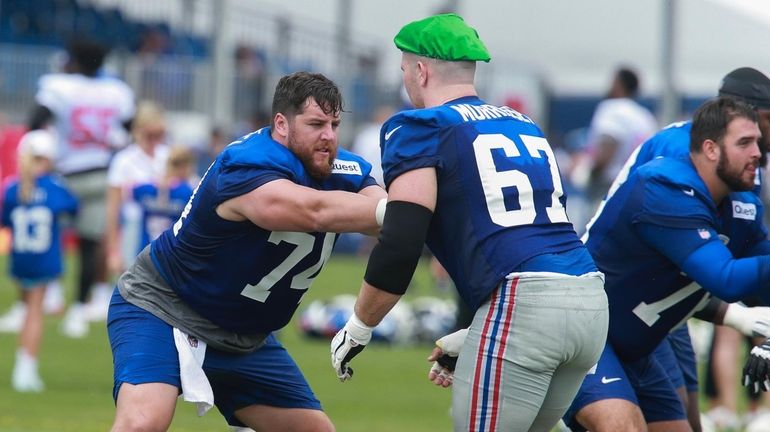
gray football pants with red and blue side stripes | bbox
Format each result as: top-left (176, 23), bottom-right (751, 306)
top-left (452, 273), bottom-right (609, 432)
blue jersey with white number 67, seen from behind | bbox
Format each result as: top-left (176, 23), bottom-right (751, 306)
top-left (380, 97), bottom-right (595, 309)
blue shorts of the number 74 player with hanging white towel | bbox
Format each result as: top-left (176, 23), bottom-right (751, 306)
top-left (107, 289), bottom-right (321, 426)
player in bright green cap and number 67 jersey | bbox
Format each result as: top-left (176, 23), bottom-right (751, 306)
top-left (331, 14), bottom-right (608, 431)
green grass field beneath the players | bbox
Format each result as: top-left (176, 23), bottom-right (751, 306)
top-left (0, 255), bottom-right (451, 432)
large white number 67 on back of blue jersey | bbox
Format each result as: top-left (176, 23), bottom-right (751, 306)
top-left (473, 134), bottom-right (568, 227)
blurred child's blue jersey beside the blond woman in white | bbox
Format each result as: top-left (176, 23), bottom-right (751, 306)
top-left (132, 182), bottom-right (192, 253)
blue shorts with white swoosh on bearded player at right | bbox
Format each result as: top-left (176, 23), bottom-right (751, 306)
top-left (564, 343), bottom-right (687, 431)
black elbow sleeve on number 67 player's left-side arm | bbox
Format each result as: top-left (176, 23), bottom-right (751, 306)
top-left (364, 201), bottom-right (433, 295)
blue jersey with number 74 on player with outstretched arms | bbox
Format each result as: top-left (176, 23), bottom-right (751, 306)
top-left (151, 128), bottom-right (376, 334)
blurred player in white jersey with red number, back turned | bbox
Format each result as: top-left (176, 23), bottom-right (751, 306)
top-left (29, 39), bottom-right (135, 337)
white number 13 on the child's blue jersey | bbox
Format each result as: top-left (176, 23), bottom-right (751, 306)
top-left (11, 206), bottom-right (53, 253)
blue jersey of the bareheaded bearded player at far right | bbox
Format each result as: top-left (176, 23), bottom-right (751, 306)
top-left (586, 157), bottom-right (767, 360)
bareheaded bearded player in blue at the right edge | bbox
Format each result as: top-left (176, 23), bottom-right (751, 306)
top-left (565, 98), bottom-right (770, 431)
